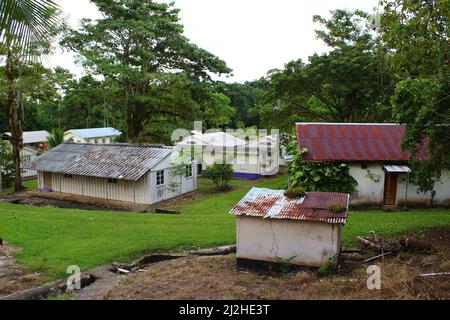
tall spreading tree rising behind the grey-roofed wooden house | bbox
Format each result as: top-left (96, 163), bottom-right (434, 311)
top-left (62, 0), bottom-right (230, 141)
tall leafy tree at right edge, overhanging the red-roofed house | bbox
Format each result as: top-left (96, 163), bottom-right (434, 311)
top-left (381, 0), bottom-right (450, 198)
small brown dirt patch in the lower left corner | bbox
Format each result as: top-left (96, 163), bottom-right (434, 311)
top-left (0, 243), bottom-right (45, 296)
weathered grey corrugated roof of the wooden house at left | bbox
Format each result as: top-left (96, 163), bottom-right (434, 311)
top-left (27, 143), bottom-right (173, 181)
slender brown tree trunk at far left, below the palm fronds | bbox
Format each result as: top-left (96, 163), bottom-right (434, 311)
top-left (6, 52), bottom-right (23, 192)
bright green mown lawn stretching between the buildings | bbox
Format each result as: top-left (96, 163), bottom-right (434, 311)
top-left (0, 177), bottom-right (450, 279)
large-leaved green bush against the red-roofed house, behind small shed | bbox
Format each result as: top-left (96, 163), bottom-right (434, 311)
top-left (288, 142), bottom-right (358, 193)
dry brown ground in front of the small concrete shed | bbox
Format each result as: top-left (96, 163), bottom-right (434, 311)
top-left (107, 229), bottom-right (450, 300)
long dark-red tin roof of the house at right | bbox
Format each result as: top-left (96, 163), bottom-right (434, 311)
top-left (297, 123), bottom-right (425, 161)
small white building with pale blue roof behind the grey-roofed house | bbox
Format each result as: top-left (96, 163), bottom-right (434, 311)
top-left (64, 127), bottom-right (122, 144)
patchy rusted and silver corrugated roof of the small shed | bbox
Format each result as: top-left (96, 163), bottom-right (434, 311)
top-left (230, 188), bottom-right (349, 224)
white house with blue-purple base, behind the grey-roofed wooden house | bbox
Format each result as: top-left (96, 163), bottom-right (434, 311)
top-left (177, 132), bottom-right (280, 179)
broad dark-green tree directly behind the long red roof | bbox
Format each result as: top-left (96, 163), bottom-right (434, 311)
top-left (260, 10), bottom-right (392, 131)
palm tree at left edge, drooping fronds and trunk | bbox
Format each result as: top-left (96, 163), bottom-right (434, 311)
top-left (0, 0), bottom-right (59, 192)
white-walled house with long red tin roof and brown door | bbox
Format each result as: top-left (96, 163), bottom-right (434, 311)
top-left (297, 123), bottom-right (450, 206)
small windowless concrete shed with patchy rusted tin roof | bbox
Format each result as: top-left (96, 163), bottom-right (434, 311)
top-left (230, 188), bottom-right (349, 267)
